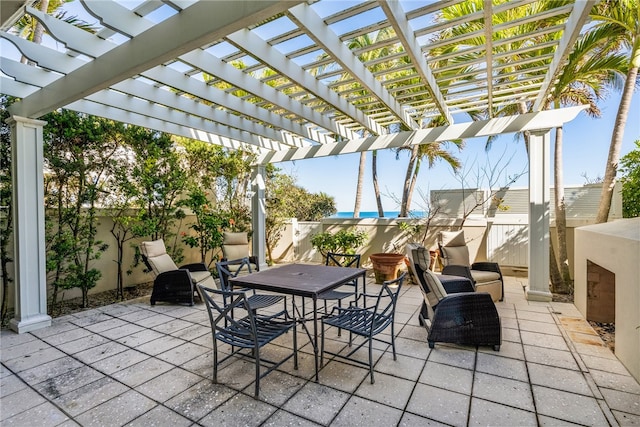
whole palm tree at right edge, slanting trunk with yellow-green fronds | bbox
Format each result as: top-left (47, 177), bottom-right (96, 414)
top-left (591, 0), bottom-right (640, 223)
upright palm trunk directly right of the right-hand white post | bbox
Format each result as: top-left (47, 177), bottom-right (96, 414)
top-left (553, 127), bottom-right (573, 293)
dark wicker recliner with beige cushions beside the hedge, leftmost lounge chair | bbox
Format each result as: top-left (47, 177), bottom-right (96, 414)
top-left (140, 239), bottom-right (216, 305)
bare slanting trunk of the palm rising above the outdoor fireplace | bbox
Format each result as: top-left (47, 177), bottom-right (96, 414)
top-left (596, 65), bottom-right (640, 224)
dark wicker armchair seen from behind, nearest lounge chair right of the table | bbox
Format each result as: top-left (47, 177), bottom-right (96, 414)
top-left (420, 270), bottom-right (502, 351)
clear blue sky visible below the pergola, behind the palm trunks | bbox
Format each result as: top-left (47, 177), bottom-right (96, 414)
top-left (284, 93), bottom-right (640, 212)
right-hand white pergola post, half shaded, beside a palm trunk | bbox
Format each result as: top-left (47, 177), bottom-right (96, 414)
top-left (527, 129), bottom-right (552, 301)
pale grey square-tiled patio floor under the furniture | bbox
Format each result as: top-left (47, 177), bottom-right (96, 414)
top-left (0, 277), bottom-right (640, 427)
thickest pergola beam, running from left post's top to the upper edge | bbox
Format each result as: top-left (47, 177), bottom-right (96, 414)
top-left (10, 0), bottom-right (302, 117)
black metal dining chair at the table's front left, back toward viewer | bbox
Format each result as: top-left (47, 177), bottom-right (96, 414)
top-left (197, 285), bottom-right (298, 399)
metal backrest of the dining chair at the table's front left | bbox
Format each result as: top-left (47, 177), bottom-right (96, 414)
top-left (197, 285), bottom-right (258, 348)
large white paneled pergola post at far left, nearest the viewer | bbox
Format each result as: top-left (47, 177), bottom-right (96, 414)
top-left (7, 116), bottom-right (51, 333)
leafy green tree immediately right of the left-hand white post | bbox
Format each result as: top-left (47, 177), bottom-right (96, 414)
top-left (44, 110), bottom-right (118, 307)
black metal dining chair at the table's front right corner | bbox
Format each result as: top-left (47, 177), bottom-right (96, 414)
top-left (320, 273), bottom-right (407, 384)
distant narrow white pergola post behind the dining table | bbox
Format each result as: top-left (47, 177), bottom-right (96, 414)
top-left (251, 166), bottom-right (267, 269)
